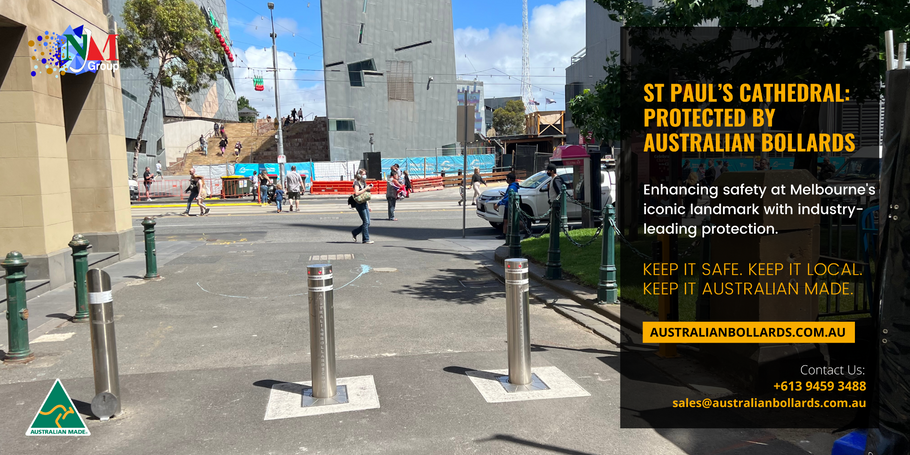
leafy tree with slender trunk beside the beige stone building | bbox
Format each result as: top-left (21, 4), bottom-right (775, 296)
top-left (118, 0), bottom-right (224, 179)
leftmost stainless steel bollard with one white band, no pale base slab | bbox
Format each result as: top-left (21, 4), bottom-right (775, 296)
top-left (87, 269), bottom-right (120, 420)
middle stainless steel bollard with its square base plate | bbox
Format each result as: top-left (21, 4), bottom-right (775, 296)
top-left (301, 264), bottom-right (348, 406)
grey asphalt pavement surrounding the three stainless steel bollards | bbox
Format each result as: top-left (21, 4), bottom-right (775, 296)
top-left (0, 197), bottom-right (828, 454)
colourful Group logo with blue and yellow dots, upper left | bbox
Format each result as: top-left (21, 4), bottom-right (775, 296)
top-left (28, 25), bottom-right (120, 78)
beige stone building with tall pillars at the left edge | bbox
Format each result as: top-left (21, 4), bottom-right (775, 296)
top-left (0, 0), bottom-right (136, 290)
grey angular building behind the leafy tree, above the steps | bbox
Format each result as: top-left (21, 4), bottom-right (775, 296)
top-left (104, 0), bottom-right (238, 174)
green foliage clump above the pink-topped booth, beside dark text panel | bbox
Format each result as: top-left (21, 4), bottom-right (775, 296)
top-left (569, 52), bottom-right (624, 147)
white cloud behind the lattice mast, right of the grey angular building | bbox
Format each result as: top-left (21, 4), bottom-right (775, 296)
top-left (455, 0), bottom-right (585, 110)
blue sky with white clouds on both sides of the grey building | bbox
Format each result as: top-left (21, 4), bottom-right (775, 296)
top-left (227, 0), bottom-right (585, 119)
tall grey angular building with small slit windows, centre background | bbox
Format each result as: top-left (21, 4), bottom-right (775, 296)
top-left (321, 0), bottom-right (458, 160)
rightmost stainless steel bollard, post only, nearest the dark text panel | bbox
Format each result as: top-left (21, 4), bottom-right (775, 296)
top-left (505, 259), bottom-right (531, 385)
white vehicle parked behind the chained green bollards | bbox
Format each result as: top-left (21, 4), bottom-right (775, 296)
top-left (476, 167), bottom-right (616, 229)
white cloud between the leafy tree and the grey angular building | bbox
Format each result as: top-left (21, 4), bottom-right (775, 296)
top-left (234, 46), bottom-right (325, 119)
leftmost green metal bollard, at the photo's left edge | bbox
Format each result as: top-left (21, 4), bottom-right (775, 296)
top-left (0, 251), bottom-right (35, 363)
